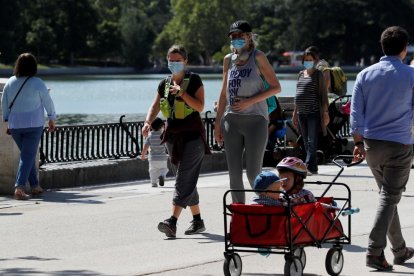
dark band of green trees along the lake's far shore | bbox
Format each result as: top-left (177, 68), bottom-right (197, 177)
top-left (0, 0), bottom-right (414, 69)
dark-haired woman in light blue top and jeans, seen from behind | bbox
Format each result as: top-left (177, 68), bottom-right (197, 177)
top-left (1, 53), bottom-right (56, 200)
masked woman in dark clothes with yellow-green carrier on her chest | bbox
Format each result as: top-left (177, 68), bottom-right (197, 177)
top-left (142, 45), bottom-right (210, 238)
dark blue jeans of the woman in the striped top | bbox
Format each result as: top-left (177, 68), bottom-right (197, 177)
top-left (298, 112), bottom-right (321, 172)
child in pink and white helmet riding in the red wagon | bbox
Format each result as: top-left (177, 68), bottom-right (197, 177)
top-left (276, 157), bottom-right (316, 205)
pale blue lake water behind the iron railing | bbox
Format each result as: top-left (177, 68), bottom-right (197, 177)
top-left (43, 74), bottom-right (355, 125)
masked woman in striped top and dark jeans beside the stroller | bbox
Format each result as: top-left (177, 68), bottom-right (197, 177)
top-left (292, 47), bottom-right (329, 175)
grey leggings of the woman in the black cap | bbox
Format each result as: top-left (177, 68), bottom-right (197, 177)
top-left (222, 114), bottom-right (268, 203)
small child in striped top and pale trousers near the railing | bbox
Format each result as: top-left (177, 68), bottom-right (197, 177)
top-left (141, 117), bottom-right (168, 187)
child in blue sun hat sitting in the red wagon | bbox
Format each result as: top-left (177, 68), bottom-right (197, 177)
top-left (251, 171), bottom-right (283, 206)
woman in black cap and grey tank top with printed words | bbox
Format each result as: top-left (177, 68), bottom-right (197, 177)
top-left (214, 20), bottom-right (281, 203)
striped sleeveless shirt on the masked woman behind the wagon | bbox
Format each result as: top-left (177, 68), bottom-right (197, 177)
top-left (295, 71), bottom-right (319, 114)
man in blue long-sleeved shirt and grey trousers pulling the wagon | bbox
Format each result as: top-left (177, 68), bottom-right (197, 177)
top-left (350, 26), bottom-right (414, 270)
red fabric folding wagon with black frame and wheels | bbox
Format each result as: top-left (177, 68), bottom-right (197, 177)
top-left (223, 156), bottom-right (361, 276)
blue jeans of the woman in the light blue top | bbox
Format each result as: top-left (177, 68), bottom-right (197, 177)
top-left (11, 127), bottom-right (43, 189)
